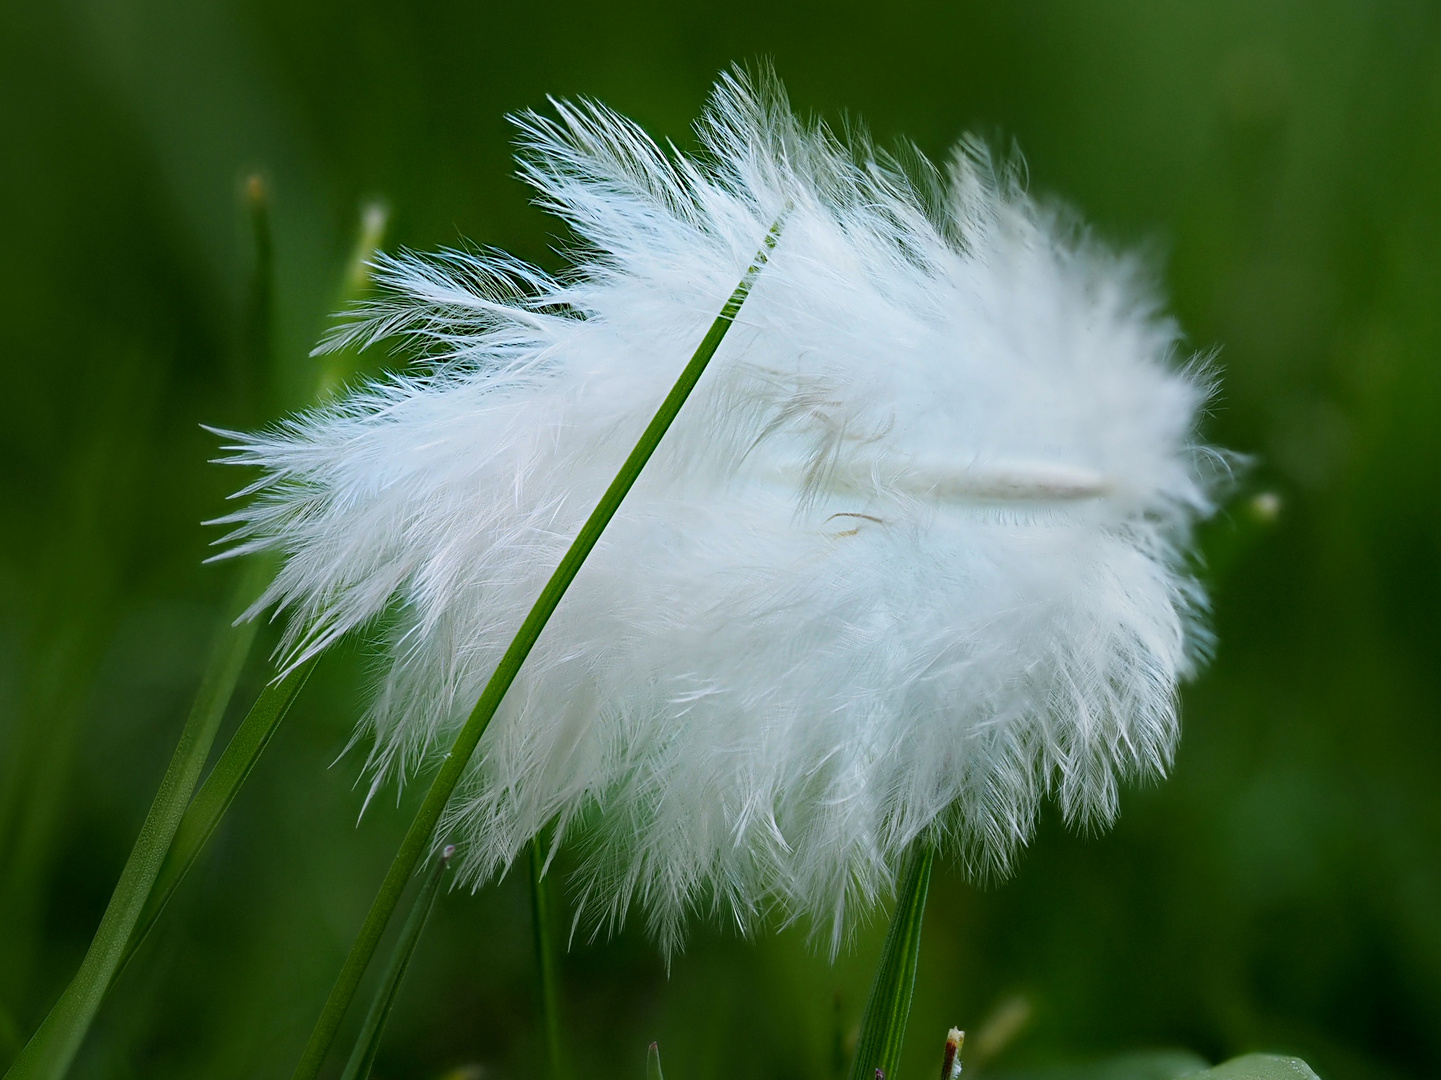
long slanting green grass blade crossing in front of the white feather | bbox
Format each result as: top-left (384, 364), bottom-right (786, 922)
top-left (294, 221), bottom-right (781, 1080)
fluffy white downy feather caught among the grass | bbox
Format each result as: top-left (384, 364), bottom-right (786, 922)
top-left (213, 75), bottom-right (1225, 947)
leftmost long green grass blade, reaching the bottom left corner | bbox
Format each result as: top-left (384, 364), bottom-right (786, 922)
top-left (6, 561), bottom-right (268, 1080)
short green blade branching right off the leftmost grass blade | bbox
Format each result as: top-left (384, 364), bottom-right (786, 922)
top-left (117, 648), bottom-right (316, 975)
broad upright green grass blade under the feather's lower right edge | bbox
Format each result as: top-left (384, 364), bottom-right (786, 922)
top-left (850, 839), bottom-right (935, 1080)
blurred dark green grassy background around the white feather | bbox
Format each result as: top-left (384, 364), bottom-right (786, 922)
top-left (0, 0), bottom-right (1441, 1080)
